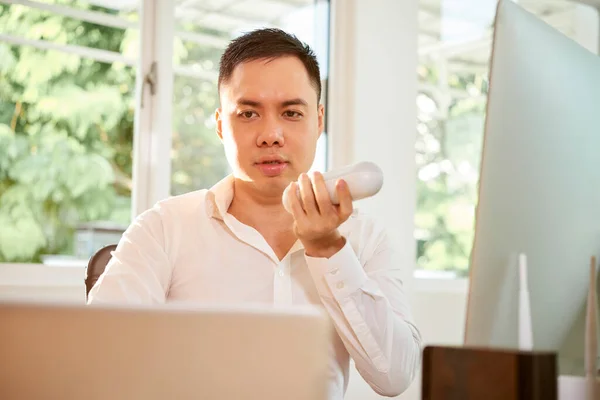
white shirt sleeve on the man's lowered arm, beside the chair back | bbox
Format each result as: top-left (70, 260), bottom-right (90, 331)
top-left (88, 206), bottom-right (172, 305)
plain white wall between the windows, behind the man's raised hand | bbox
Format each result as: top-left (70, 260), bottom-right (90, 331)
top-left (328, 0), bottom-right (466, 400)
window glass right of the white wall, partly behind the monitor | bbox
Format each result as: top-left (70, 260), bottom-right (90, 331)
top-left (415, 0), bottom-right (598, 276)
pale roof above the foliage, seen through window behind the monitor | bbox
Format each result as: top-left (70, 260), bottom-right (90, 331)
top-left (418, 0), bottom-right (600, 112)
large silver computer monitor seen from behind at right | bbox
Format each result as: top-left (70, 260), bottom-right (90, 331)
top-left (465, 0), bottom-right (600, 374)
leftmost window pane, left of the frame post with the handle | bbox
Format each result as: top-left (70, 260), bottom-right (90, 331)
top-left (0, 1), bottom-right (137, 265)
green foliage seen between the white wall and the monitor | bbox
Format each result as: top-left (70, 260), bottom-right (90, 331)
top-left (415, 66), bottom-right (487, 275)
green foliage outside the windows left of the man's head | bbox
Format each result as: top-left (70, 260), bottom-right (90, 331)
top-left (0, 0), bottom-right (229, 262)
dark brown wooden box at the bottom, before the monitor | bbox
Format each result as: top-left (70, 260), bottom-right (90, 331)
top-left (422, 346), bottom-right (558, 400)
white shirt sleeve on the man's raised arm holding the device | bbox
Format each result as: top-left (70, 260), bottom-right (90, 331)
top-left (305, 228), bottom-right (422, 396)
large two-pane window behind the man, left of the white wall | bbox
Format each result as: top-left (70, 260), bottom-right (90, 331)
top-left (0, 0), bottom-right (329, 265)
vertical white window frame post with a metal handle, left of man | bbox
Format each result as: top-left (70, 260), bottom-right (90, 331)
top-left (131, 0), bottom-right (175, 221)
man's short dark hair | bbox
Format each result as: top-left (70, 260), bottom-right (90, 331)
top-left (218, 28), bottom-right (321, 102)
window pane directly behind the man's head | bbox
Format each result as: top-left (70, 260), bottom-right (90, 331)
top-left (171, 0), bottom-right (329, 195)
